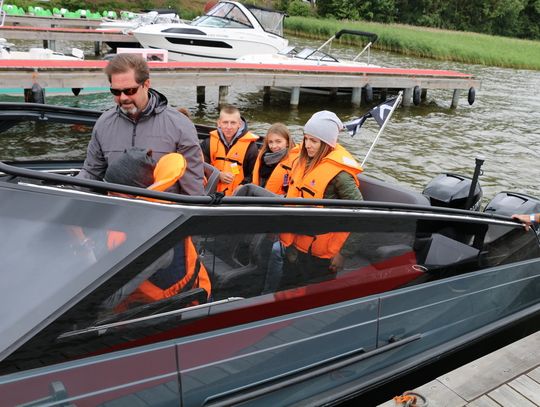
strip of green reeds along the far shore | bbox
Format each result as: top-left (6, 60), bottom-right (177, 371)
top-left (285, 17), bottom-right (540, 70)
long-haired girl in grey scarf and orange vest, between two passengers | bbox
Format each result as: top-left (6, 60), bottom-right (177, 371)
top-left (253, 123), bottom-right (300, 195)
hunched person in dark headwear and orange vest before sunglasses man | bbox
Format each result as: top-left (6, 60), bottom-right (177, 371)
top-left (100, 147), bottom-right (211, 312)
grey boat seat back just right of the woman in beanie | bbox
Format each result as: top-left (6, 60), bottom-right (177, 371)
top-left (358, 174), bottom-right (430, 206)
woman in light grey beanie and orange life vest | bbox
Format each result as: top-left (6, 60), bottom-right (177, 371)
top-left (280, 110), bottom-right (362, 288)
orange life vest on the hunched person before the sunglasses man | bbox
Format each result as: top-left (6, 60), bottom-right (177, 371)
top-left (107, 153), bottom-right (212, 312)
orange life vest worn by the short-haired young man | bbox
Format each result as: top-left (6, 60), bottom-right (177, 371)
top-left (210, 130), bottom-right (259, 195)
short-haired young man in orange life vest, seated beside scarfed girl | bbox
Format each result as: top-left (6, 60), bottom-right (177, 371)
top-left (201, 106), bottom-right (259, 195)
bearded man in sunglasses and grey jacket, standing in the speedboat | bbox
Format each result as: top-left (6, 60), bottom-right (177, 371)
top-left (79, 54), bottom-right (204, 195)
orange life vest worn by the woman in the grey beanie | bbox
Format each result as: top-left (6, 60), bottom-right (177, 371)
top-left (280, 144), bottom-right (362, 259)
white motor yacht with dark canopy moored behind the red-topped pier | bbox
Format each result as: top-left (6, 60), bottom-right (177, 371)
top-left (133, 1), bottom-right (288, 61)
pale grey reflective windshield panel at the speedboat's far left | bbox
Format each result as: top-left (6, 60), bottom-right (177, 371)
top-left (0, 186), bottom-right (178, 359)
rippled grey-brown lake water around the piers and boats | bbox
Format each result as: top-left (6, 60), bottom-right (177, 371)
top-left (0, 37), bottom-right (540, 201)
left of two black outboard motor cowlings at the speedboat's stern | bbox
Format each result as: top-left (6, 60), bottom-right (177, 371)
top-left (422, 173), bottom-right (484, 211)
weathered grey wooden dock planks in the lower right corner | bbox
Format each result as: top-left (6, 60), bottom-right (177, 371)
top-left (379, 332), bottom-right (540, 407)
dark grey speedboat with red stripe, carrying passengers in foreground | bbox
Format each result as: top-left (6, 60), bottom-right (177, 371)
top-left (0, 105), bottom-right (540, 406)
